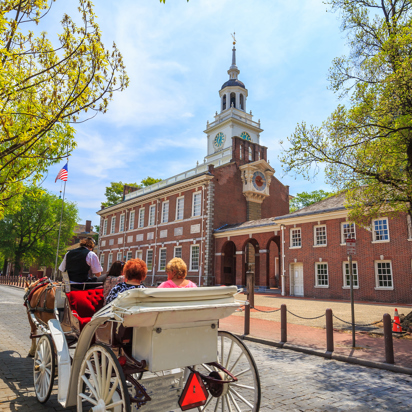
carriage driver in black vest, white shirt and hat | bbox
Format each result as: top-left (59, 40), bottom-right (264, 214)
top-left (59, 237), bottom-right (106, 283)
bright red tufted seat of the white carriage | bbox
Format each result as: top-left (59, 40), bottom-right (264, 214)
top-left (66, 289), bottom-right (104, 331)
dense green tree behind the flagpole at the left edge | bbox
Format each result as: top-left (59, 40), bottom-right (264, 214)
top-left (0, 186), bottom-right (78, 274)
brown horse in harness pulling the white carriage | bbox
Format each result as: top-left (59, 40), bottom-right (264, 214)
top-left (24, 277), bottom-right (58, 357)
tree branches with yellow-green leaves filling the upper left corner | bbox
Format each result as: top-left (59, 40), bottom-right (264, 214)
top-left (0, 0), bottom-right (128, 218)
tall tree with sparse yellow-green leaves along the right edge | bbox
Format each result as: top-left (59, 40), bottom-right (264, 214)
top-left (281, 0), bottom-right (412, 224)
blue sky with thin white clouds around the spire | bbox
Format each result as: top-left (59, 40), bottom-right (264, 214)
top-left (42, 0), bottom-right (347, 225)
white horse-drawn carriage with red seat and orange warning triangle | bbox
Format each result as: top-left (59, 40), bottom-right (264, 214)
top-left (28, 284), bottom-right (260, 412)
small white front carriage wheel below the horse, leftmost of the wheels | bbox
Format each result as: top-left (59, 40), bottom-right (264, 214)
top-left (33, 335), bottom-right (56, 403)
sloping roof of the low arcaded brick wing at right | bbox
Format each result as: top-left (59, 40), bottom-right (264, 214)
top-left (214, 193), bottom-right (345, 232)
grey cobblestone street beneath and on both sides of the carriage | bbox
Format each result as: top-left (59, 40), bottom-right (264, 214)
top-left (0, 286), bottom-right (412, 412)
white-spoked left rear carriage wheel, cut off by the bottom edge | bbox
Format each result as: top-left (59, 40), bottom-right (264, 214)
top-left (77, 344), bottom-right (130, 412)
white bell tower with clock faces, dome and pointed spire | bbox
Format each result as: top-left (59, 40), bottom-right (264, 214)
top-left (204, 34), bottom-right (263, 163)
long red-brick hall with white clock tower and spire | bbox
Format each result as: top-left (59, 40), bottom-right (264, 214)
top-left (98, 42), bottom-right (289, 286)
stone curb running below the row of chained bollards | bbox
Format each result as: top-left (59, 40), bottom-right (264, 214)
top-left (236, 335), bottom-right (412, 375)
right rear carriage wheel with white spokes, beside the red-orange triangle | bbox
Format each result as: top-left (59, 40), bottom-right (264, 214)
top-left (196, 331), bottom-right (261, 412)
